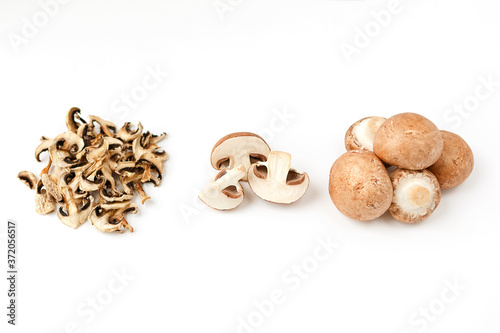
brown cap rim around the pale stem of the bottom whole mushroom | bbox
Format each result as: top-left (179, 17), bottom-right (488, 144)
top-left (389, 169), bottom-right (441, 223)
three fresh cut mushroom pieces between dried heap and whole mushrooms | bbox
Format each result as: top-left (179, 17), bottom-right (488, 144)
top-left (199, 132), bottom-right (309, 210)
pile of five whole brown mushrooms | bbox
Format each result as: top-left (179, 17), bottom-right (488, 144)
top-left (329, 113), bottom-right (474, 223)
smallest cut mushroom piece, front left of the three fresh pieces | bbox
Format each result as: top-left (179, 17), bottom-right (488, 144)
top-left (198, 165), bottom-right (246, 210)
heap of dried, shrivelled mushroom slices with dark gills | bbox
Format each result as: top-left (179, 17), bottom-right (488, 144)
top-left (18, 108), bottom-right (167, 232)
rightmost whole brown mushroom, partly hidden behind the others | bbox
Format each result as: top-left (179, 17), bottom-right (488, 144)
top-left (429, 131), bottom-right (474, 190)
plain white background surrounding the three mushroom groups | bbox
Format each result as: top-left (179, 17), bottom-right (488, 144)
top-left (0, 0), bottom-right (500, 333)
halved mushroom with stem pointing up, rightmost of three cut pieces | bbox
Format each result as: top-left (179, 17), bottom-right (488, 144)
top-left (248, 151), bottom-right (309, 204)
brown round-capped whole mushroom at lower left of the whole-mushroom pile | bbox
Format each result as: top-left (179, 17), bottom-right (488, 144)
top-left (329, 150), bottom-right (392, 221)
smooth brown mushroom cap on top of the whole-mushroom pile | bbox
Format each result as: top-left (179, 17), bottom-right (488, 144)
top-left (373, 112), bottom-right (443, 170)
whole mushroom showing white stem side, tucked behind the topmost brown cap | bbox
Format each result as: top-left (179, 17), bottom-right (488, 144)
top-left (344, 116), bottom-right (387, 151)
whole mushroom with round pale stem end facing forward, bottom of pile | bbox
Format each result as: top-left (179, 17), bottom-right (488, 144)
top-left (389, 169), bottom-right (441, 223)
